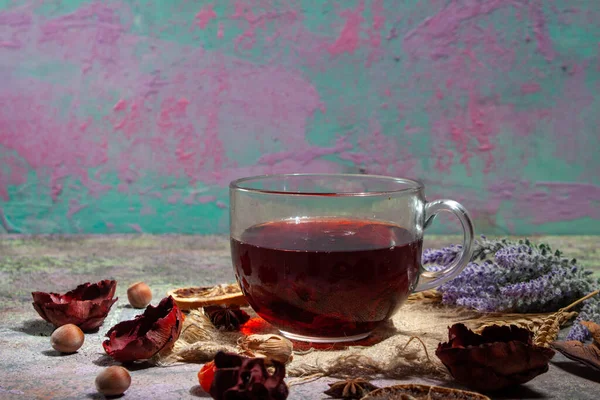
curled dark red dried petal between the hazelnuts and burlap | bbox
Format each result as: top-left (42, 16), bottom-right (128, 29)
top-left (102, 296), bottom-right (183, 362)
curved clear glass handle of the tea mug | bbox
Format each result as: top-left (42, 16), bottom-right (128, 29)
top-left (414, 200), bottom-right (473, 292)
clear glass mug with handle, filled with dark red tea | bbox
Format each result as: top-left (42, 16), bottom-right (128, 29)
top-left (229, 174), bottom-right (473, 343)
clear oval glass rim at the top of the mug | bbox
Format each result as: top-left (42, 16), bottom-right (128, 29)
top-left (229, 173), bottom-right (424, 197)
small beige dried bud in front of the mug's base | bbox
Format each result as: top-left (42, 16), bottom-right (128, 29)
top-left (238, 334), bottom-right (294, 365)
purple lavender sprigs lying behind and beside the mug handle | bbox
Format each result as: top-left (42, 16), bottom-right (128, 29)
top-left (423, 236), bottom-right (600, 338)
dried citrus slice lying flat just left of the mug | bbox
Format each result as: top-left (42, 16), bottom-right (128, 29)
top-left (167, 283), bottom-right (248, 310)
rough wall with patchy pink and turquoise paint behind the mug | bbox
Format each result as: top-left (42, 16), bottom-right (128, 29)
top-left (0, 0), bottom-right (600, 234)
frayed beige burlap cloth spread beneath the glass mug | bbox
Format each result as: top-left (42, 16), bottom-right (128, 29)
top-left (155, 295), bottom-right (488, 379)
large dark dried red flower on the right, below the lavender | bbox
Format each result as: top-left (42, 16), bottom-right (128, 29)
top-left (435, 324), bottom-right (554, 391)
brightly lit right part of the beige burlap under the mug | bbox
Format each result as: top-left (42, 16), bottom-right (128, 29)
top-left (288, 301), bottom-right (479, 378)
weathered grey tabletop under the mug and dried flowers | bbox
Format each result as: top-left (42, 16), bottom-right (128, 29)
top-left (0, 235), bottom-right (600, 400)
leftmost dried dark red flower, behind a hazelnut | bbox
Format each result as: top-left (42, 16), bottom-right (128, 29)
top-left (31, 280), bottom-right (118, 332)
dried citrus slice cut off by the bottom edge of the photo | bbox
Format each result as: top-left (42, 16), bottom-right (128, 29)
top-left (362, 384), bottom-right (490, 400)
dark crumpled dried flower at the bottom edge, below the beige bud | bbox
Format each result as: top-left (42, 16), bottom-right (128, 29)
top-left (210, 352), bottom-right (289, 400)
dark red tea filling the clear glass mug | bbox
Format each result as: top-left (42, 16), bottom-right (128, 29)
top-left (231, 218), bottom-right (422, 338)
